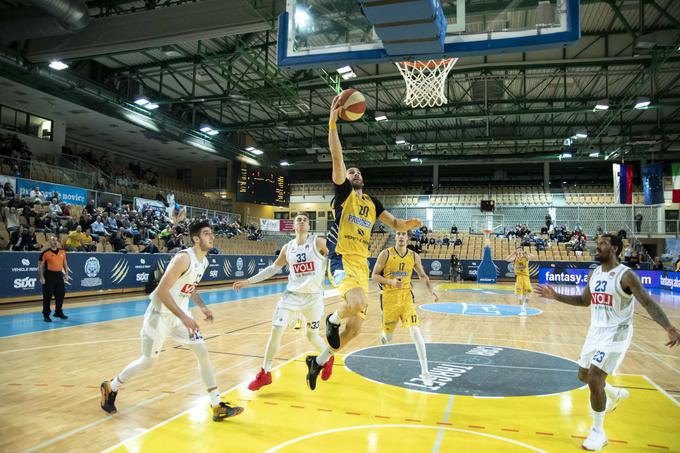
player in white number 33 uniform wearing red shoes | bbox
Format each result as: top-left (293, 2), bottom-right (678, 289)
top-left (234, 212), bottom-right (333, 390)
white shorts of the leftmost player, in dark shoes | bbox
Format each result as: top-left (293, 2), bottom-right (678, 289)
top-left (139, 304), bottom-right (203, 357)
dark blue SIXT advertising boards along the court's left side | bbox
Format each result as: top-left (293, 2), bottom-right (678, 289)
top-left (0, 252), bottom-right (287, 298)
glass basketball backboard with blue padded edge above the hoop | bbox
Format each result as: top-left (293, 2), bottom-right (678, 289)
top-left (278, 0), bottom-right (580, 69)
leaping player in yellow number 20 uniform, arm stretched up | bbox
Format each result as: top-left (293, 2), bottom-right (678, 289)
top-left (306, 92), bottom-right (421, 390)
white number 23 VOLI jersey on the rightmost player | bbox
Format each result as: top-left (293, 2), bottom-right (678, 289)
top-left (588, 264), bottom-right (635, 327)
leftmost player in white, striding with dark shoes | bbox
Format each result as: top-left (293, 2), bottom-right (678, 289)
top-left (100, 220), bottom-right (243, 421)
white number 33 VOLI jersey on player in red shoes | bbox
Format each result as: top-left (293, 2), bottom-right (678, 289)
top-left (286, 234), bottom-right (326, 294)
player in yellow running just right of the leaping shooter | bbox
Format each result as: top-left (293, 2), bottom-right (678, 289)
top-left (372, 231), bottom-right (438, 387)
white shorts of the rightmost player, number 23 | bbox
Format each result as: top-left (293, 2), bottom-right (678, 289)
top-left (578, 324), bottom-right (633, 374)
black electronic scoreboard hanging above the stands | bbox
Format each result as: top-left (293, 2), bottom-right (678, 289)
top-left (236, 165), bottom-right (290, 207)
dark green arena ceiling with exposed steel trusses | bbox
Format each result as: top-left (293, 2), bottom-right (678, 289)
top-left (0, 0), bottom-right (680, 168)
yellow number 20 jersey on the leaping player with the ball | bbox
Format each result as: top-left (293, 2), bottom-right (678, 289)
top-left (327, 179), bottom-right (385, 258)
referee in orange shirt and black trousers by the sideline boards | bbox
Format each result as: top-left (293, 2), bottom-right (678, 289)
top-left (38, 236), bottom-right (69, 322)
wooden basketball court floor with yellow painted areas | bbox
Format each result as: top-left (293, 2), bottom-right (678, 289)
top-left (0, 283), bottom-right (680, 452)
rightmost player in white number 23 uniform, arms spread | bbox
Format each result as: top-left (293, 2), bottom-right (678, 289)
top-left (536, 234), bottom-right (680, 450)
